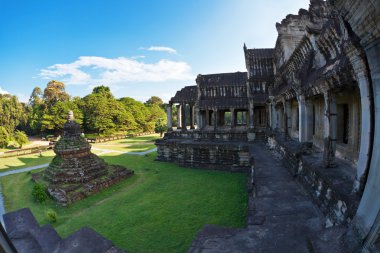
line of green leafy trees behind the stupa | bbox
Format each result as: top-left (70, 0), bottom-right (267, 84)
top-left (0, 80), bottom-right (167, 147)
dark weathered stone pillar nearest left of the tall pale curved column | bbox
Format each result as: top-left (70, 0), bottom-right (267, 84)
top-left (323, 91), bottom-right (337, 167)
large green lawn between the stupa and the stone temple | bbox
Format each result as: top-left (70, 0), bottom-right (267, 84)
top-left (1, 151), bottom-right (247, 252)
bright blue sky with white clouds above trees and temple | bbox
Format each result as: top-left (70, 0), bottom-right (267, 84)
top-left (0, 0), bottom-right (309, 101)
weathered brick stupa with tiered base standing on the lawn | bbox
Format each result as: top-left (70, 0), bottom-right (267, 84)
top-left (43, 111), bottom-right (133, 205)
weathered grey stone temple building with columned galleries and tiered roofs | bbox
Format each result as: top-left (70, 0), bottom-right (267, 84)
top-left (156, 0), bottom-right (380, 252)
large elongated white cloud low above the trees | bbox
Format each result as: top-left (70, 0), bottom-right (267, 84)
top-left (39, 56), bottom-right (194, 85)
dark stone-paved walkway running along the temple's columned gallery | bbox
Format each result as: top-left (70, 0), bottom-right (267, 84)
top-left (189, 142), bottom-right (342, 253)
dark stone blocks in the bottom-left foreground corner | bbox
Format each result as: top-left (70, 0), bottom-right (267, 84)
top-left (0, 208), bottom-right (127, 253)
